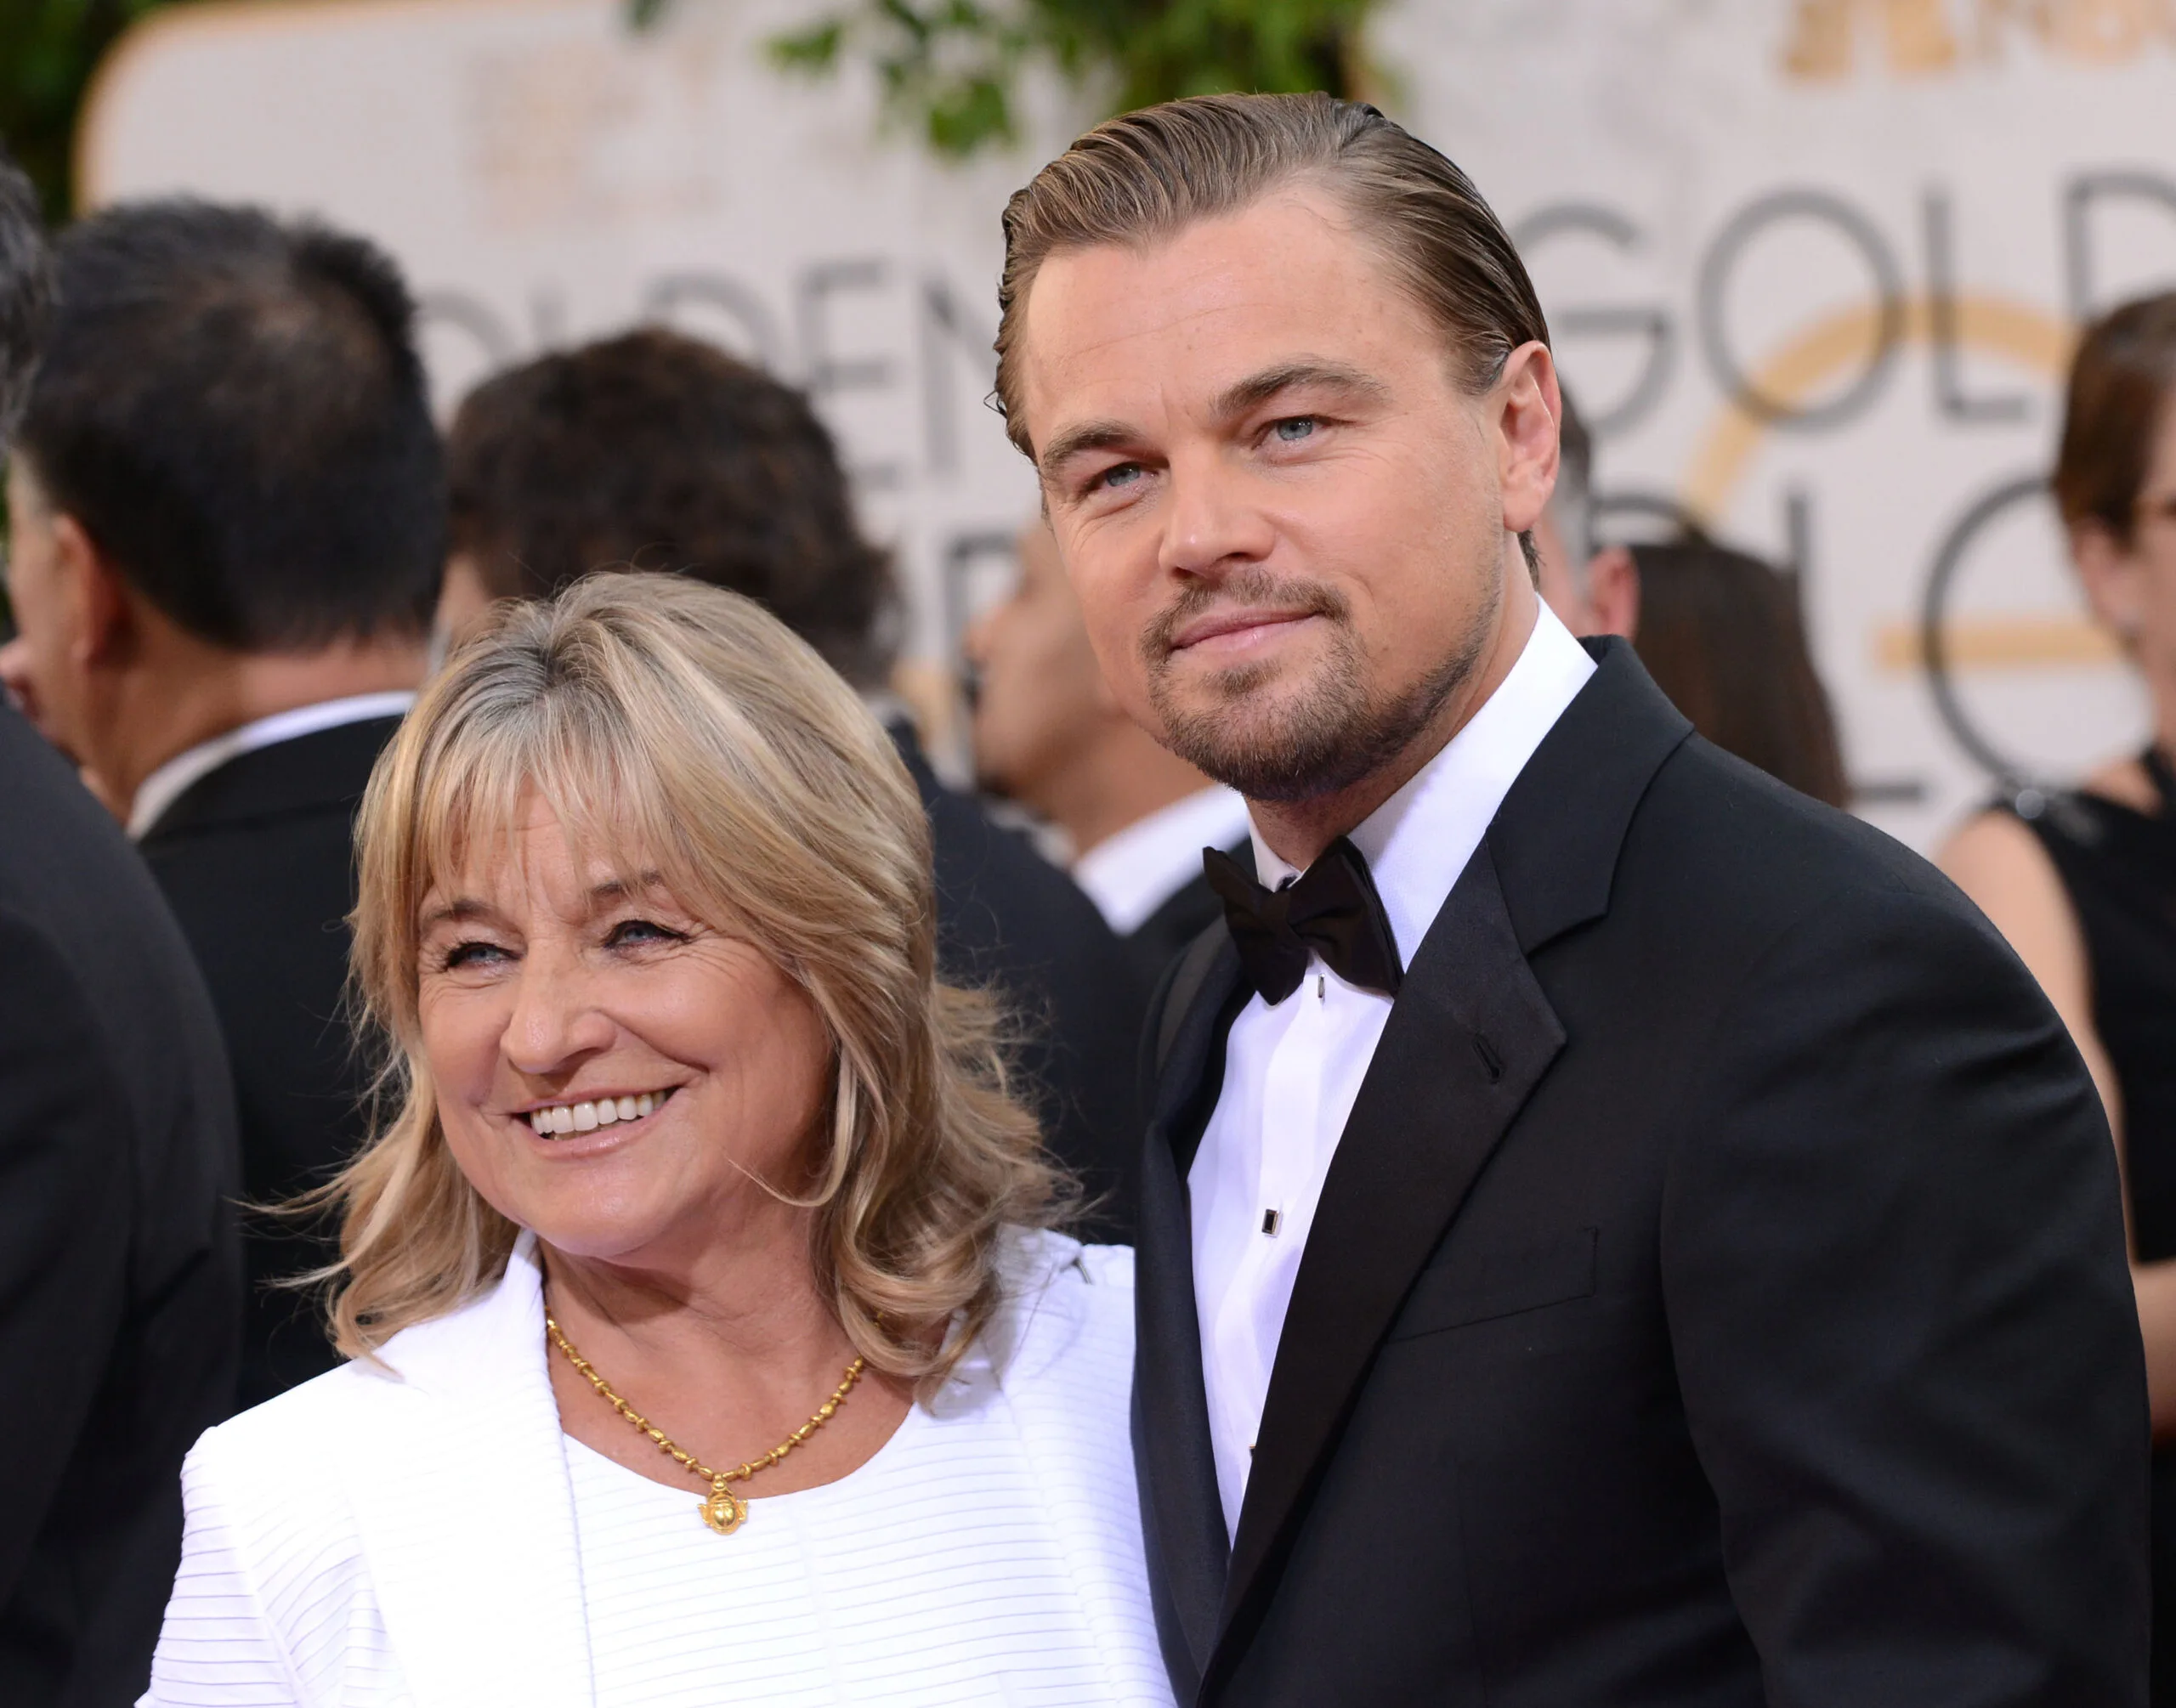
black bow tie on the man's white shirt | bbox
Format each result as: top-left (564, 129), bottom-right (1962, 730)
top-left (1201, 835), bottom-right (1403, 1008)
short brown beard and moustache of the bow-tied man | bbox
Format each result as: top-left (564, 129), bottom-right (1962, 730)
top-left (1140, 572), bottom-right (1504, 800)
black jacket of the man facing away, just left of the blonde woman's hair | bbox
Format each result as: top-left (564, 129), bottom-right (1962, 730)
top-left (137, 718), bottom-right (400, 1405)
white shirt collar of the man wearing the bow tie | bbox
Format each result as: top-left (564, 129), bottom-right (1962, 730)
top-left (1254, 601), bottom-right (1595, 966)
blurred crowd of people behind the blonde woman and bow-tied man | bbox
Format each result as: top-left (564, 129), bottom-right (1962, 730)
top-left (0, 116), bottom-right (2176, 1701)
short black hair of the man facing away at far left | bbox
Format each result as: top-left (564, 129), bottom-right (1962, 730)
top-left (22, 198), bottom-right (446, 653)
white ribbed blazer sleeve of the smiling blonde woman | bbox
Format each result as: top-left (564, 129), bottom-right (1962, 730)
top-left (137, 1434), bottom-right (307, 1708)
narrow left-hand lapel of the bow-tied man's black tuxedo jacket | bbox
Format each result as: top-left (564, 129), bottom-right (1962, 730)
top-left (1134, 942), bottom-right (1244, 1700)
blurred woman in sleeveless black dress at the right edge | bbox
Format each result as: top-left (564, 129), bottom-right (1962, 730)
top-left (1943, 294), bottom-right (2176, 1704)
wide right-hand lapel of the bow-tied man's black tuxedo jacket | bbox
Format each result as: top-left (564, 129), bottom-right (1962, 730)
top-left (1219, 642), bottom-right (1691, 1660)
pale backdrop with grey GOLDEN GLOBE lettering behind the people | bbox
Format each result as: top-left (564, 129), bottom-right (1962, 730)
top-left (81, 0), bottom-right (2176, 846)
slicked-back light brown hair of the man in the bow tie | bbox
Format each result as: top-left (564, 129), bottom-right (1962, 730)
top-left (996, 93), bottom-right (1550, 457)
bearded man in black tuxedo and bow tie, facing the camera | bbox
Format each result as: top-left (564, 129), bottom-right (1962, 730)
top-left (999, 96), bottom-right (2145, 1708)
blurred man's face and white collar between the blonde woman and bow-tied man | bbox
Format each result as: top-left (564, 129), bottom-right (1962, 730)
top-left (966, 520), bottom-right (1254, 986)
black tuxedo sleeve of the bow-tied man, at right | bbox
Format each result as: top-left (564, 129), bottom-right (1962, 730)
top-left (1660, 888), bottom-right (2148, 1708)
